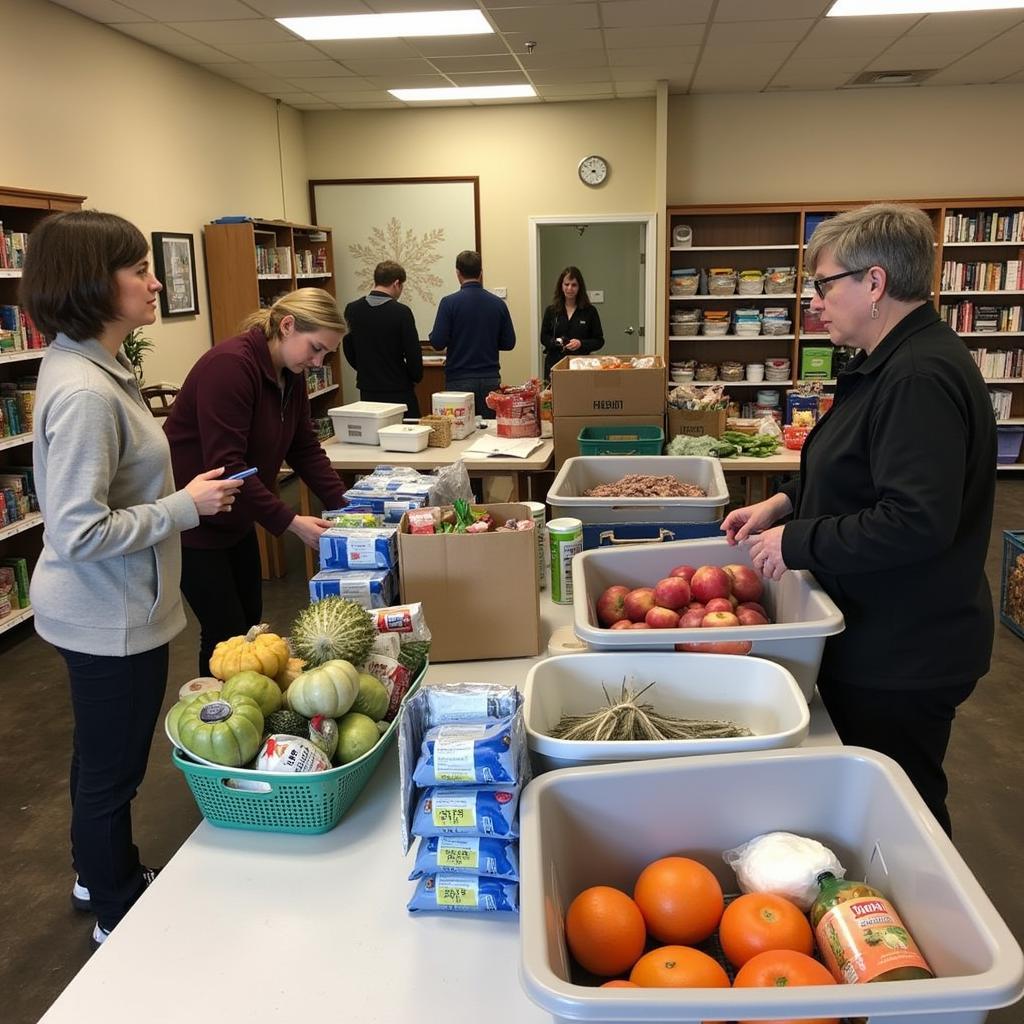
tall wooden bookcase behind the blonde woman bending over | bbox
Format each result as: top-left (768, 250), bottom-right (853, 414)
top-left (203, 220), bottom-right (344, 580)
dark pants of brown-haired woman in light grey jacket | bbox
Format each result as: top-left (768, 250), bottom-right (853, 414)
top-left (57, 644), bottom-right (168, 931)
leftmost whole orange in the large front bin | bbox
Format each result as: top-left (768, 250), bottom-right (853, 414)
top-left (565, 886), bottom-right (647, 978)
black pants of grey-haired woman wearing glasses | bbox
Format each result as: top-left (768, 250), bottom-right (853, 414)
top-left (818, 678), bottom-right (976, 836)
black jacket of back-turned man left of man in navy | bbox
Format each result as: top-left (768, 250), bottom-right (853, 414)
top-left (343, 292), bottom-right (423, 393)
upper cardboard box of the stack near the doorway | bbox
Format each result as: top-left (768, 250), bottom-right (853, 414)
top-left (551, 353), bottom-right (667, 419)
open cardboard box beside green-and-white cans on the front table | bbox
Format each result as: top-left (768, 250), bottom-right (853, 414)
top-left (398, 504), bottom-right (541, 663)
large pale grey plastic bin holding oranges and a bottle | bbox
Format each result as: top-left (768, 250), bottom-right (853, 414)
top-left (519, 746), bottom-right (1024, 1024)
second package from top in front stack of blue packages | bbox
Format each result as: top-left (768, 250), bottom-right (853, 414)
top-left (413, 718), bottom-right (521, 785)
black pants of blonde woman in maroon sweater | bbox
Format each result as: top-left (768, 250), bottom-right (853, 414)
top-left (181, 529), bottom-right (263, 676)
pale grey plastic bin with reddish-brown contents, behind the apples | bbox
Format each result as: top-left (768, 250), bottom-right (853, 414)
top-left (548, 455), bottom-right (729, 524)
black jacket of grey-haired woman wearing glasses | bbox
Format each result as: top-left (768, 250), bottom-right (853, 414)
top-left (782, 305), bottom-right (996, 689)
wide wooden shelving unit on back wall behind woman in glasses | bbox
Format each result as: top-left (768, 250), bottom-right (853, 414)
top-left (664, 197), bottom-right (1024, 469)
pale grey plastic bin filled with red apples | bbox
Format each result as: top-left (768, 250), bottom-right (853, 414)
top-left (573, 536), bottom-right (845, 700)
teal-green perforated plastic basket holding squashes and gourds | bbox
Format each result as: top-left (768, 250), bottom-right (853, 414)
top-left (171, 665), bottom-right (427, 835)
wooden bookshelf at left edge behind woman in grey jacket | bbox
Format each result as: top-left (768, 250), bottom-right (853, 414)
top-left (0, 185), bottom-right (85, 634)
